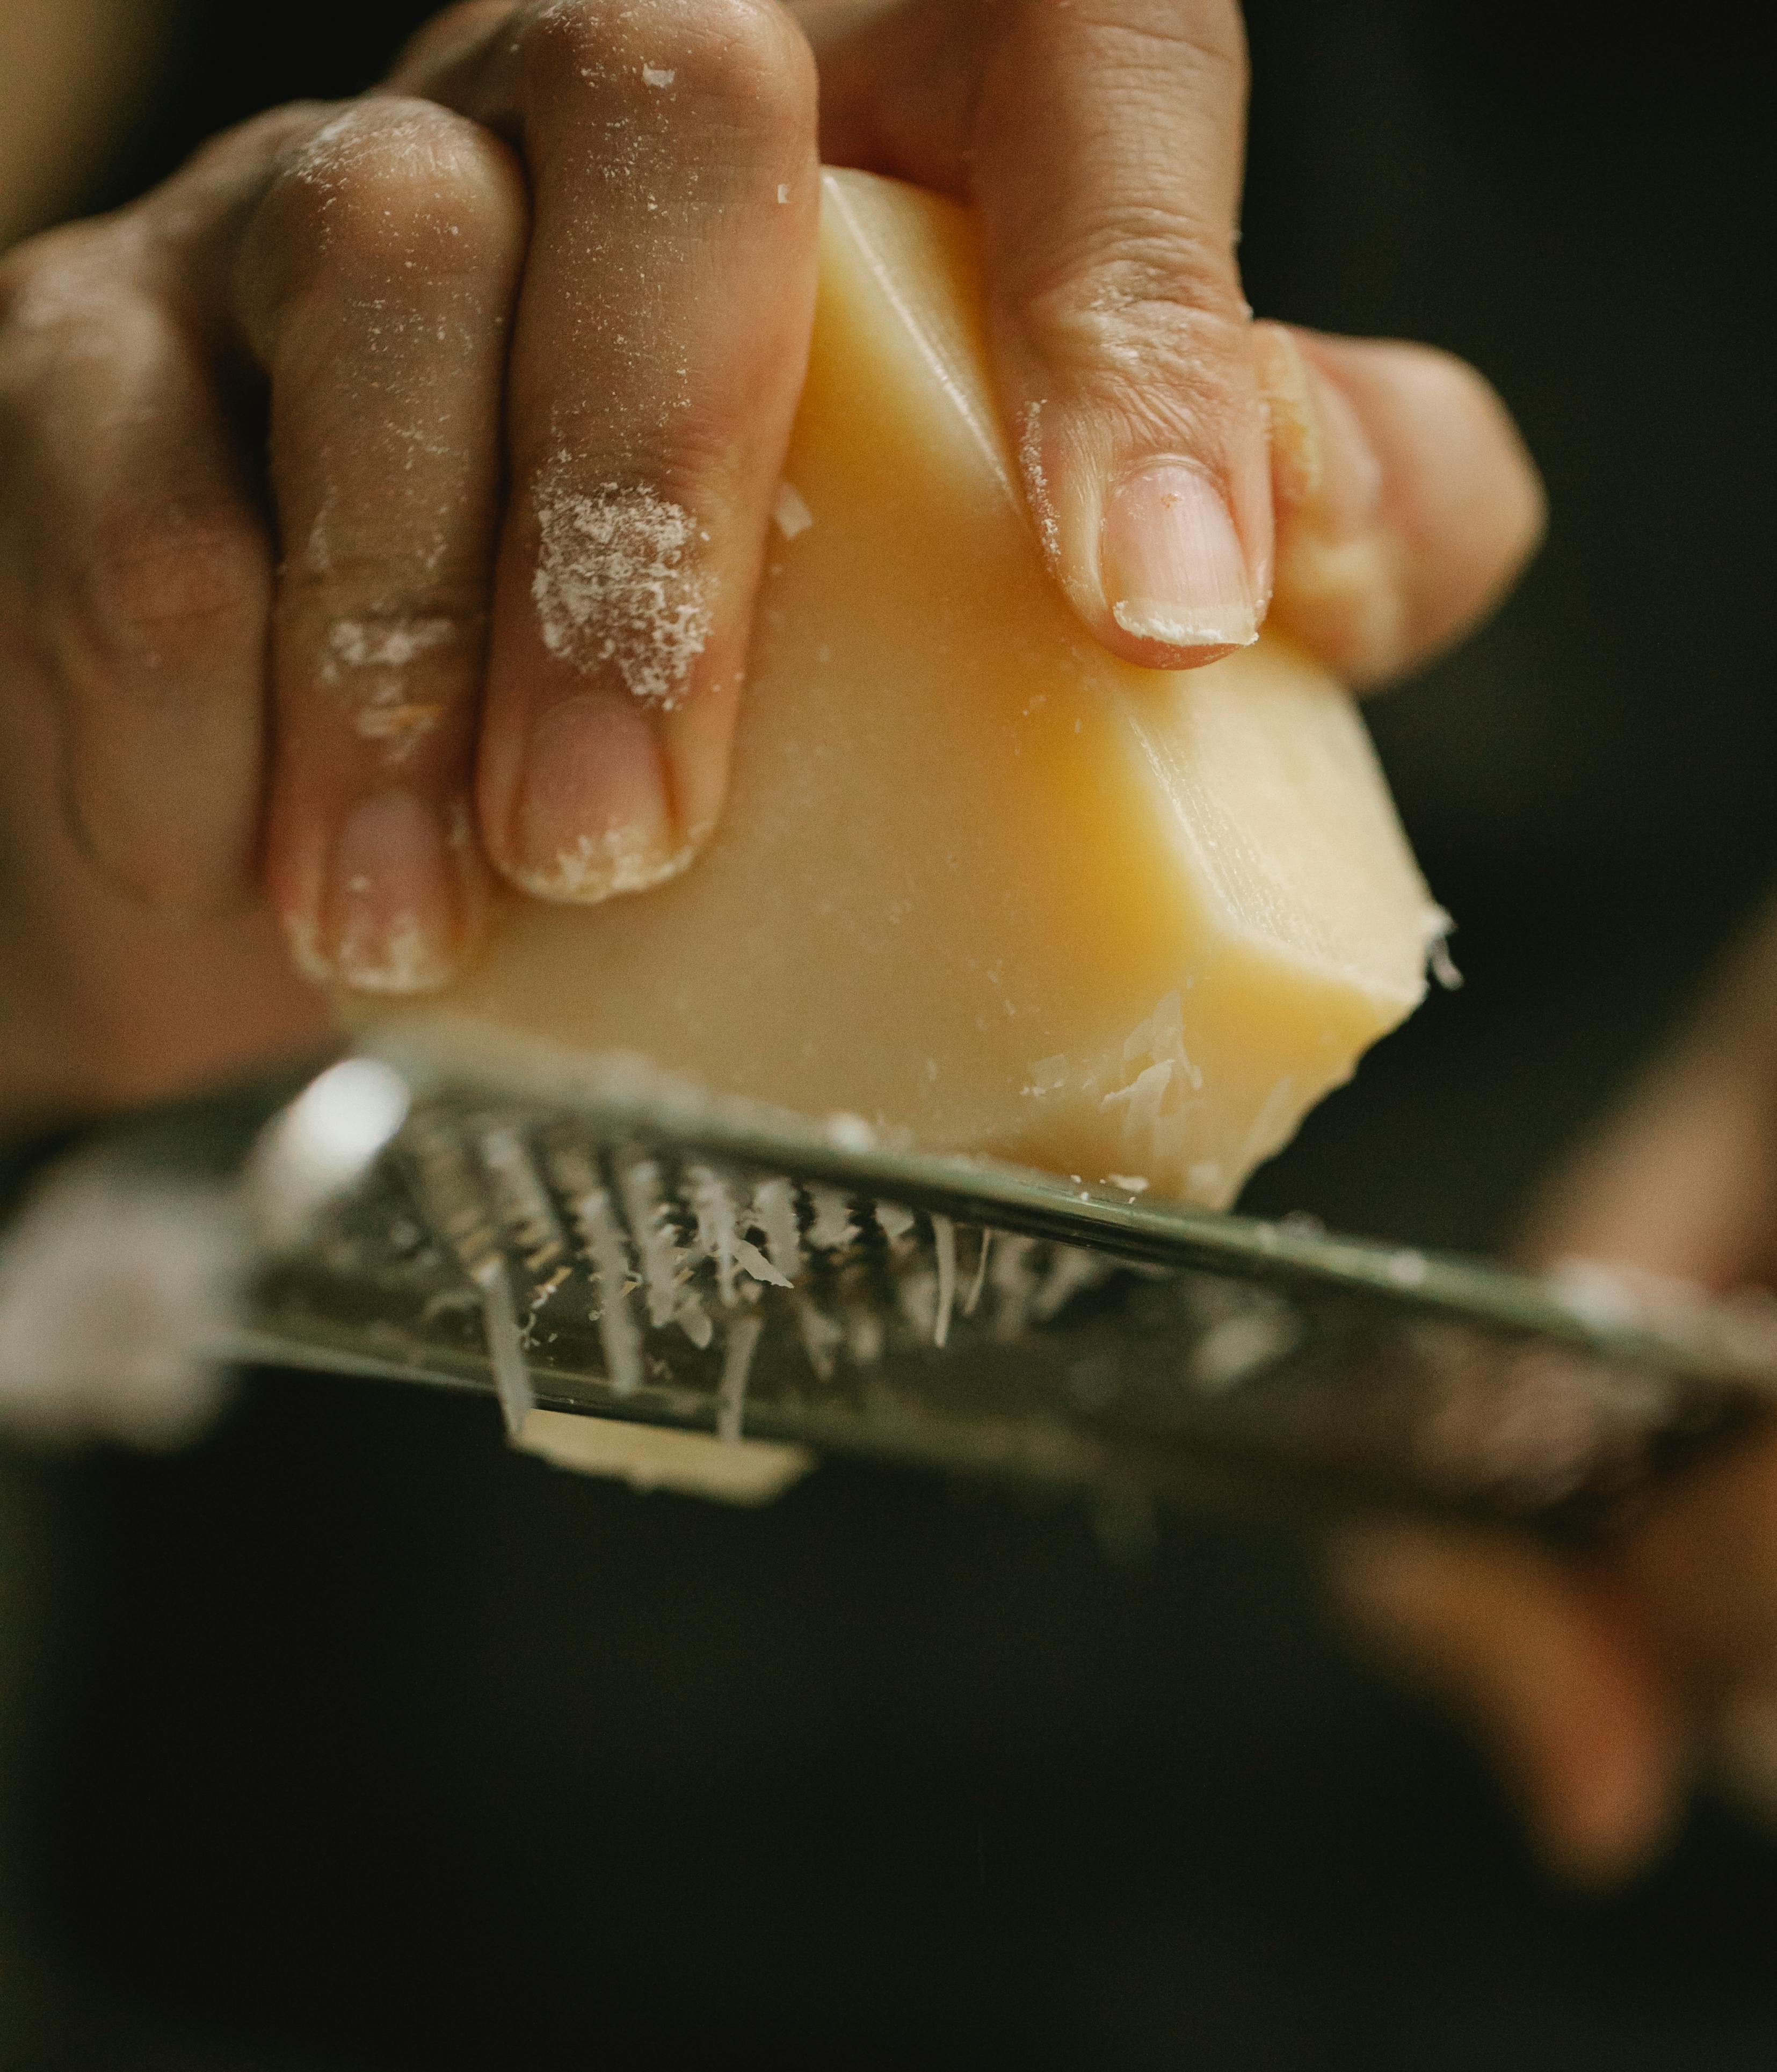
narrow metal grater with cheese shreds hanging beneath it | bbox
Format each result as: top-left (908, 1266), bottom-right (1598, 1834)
top-left (3, 1028), bottom-right (1777, 1529)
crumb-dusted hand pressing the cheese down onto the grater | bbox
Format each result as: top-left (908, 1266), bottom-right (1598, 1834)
top-left (0, 0), bottom-right (1541, 1127)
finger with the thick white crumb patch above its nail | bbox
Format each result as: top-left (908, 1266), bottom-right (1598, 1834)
top-left (414, 0), bottom-right (818, 901)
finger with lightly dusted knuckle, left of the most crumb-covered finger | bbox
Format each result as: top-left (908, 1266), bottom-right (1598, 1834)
top-left (240, 97), bottom-right (526, 992)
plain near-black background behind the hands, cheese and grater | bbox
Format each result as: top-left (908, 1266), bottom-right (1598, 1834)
top-left (0, 0), bottom-right (1777, 2072)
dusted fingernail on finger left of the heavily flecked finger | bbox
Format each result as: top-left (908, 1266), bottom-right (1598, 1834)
top-left (304, 792), bottom-right (468, 992)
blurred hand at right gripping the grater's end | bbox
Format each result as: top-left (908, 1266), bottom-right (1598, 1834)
top-left (1332, 910), bottom-right (1777, 1883)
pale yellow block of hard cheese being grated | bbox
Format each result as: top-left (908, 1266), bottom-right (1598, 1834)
top-left (356, 172), bottom-right (1439, 1204)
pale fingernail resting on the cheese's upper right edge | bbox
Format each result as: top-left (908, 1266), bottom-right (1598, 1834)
top-left (1100, 462), bottom-right (1259, 649)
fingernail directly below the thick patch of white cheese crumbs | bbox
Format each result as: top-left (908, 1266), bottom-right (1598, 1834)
top-left (513, 692), bottom-right (692, 905)
